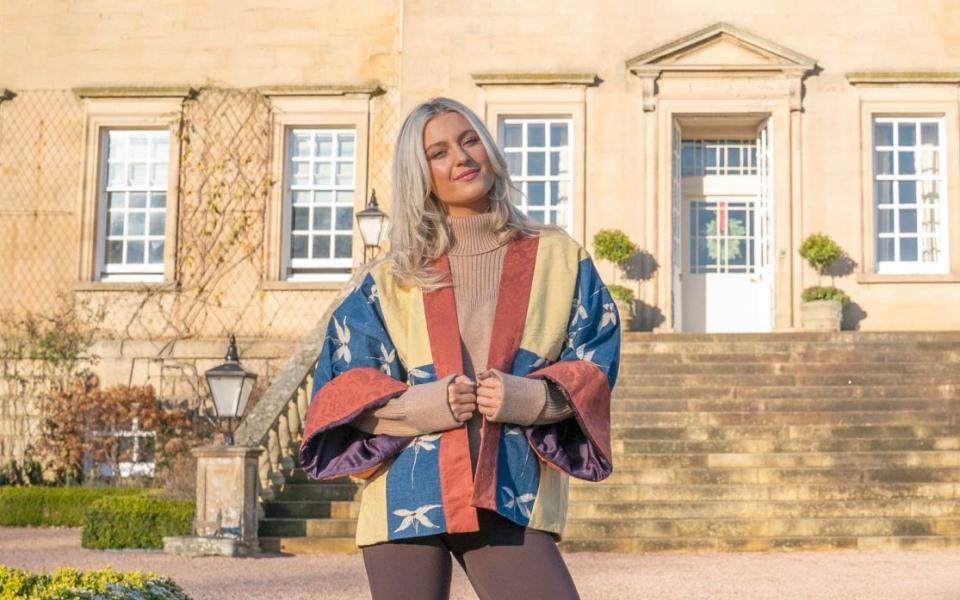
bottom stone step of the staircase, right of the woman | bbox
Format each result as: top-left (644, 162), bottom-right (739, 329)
top-left (559, 535), bottom-right (960, 553)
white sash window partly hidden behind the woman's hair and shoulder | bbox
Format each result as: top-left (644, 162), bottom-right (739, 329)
top-left (499, 117), bottom-right (573, 231)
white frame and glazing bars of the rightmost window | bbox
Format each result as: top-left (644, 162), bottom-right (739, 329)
top-left (870, 114), bottom-right (950, 275)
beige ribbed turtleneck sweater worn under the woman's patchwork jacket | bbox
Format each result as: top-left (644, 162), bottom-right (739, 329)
top-left (351, 212), bottom-right (573, 469)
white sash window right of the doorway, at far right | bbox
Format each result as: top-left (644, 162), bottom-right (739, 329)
top-left (872, 117), bottom-right (948, 274)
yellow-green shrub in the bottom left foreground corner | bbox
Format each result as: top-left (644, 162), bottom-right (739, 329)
top-left (0, 565), bottom-right (189, 600)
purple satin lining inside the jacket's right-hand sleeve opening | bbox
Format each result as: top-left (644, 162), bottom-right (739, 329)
top-left (525, 416), bottom-right (613, 481)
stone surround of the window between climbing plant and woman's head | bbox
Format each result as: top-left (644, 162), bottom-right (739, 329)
top-left (260, 83), bottom-right (382, 290)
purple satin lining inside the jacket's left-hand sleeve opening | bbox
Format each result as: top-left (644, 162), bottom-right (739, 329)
top-left (300, 398), bottom-right (413, 479)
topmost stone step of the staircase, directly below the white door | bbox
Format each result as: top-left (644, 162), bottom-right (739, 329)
top-left (622, 330), bottom-right (960, 343)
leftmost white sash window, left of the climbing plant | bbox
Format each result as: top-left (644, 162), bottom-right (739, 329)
top-left (97, 129), bottom-right (170, 281)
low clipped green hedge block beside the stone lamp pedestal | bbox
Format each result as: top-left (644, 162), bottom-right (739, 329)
top-left (81, 496), bottom-right (193, 549)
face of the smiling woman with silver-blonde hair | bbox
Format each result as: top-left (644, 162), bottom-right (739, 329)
top-left (423, 112), bottom-right (495, 216)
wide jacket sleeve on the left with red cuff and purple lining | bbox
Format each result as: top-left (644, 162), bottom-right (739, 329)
top-left (300, 275), bottom-right (413, 479)
